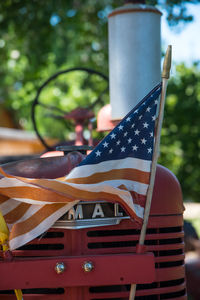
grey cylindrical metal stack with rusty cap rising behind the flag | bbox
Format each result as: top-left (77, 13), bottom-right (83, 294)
top-left (108, 1), bottom-right (162, 121)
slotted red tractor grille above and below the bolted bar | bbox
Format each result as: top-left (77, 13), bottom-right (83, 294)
top-left (0, 215), bottom-right (187, 300)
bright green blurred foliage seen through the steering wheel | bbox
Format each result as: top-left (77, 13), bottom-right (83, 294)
top-left (32, 68), bottom-right (109, 141)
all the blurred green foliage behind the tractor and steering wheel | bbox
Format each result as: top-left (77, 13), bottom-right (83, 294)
top-left (0, 0), bottom-right (200, 201)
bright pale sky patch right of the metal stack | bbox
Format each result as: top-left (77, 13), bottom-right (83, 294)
top-left (161, 4), bottom-right (200, 65)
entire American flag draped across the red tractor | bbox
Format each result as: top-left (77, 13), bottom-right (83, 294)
top-left (0, 83), bottom-right (161, 250)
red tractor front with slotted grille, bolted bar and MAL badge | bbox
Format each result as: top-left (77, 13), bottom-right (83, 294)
top-left (0, 166), bottom-right (187, 300)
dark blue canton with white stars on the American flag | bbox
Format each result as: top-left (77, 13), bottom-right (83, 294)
top-left (79, 83), bottom-right (161, 166)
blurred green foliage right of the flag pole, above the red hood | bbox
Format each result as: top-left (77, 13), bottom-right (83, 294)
top-left (160, 63), bottom-right (200, 201)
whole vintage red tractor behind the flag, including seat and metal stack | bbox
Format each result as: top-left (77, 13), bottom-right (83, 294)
top-left (0, 1), bottom-right (187, 300)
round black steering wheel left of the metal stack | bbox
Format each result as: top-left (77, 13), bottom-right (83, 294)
top-left (31, 67), bottom-right (109, 150)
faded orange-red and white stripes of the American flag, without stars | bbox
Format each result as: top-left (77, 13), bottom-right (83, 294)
top-left (0, 157), bottom-right (151, 250)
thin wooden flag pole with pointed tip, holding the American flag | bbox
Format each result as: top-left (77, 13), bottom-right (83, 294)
top-left (129, 45), bottom-right (172, 300)
